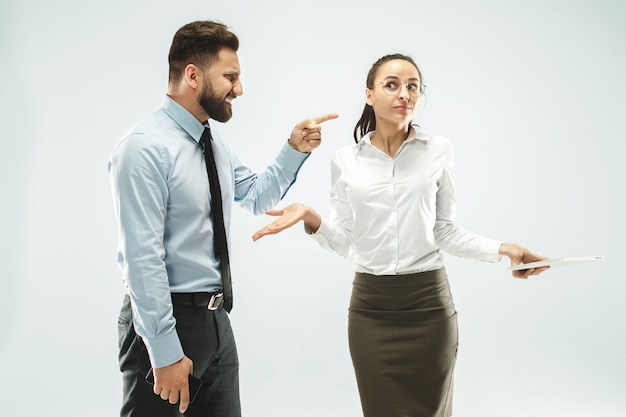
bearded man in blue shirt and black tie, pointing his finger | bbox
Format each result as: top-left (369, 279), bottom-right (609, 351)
top-left (109, 21), bottom-right (337, 417)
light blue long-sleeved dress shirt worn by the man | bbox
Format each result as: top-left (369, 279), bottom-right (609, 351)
top-left (108, 96), bottom-right (309, 368)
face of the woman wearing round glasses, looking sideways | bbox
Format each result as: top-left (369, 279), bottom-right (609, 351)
top-left (365, 59), bottom-right (422, 129)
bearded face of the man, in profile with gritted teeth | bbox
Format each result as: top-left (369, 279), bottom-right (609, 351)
top-left (198, 48), bottom-right (243, 122)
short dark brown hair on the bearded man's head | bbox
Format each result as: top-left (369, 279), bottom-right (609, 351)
top-left (168, 20), bottom-right (239, 83)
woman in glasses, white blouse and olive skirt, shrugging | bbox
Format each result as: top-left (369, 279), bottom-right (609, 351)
top-left (253, 54), bottom-right (546, 417)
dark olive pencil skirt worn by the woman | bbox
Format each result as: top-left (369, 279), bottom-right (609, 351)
top-left (348, 268), bottom-right (458, 417)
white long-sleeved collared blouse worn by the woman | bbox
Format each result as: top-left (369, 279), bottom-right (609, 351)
top-left (311, 128), bottom-right (502, 275)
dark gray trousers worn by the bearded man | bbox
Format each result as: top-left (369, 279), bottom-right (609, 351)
top-left (118, 295), bottom-right (241, 417)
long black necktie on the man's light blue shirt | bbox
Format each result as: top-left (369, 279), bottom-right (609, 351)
top-left (200, 125), bottom-right (233, 311)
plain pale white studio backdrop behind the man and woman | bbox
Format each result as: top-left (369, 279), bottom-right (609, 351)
top-left (0, 0), bottom-right (626, 417)
